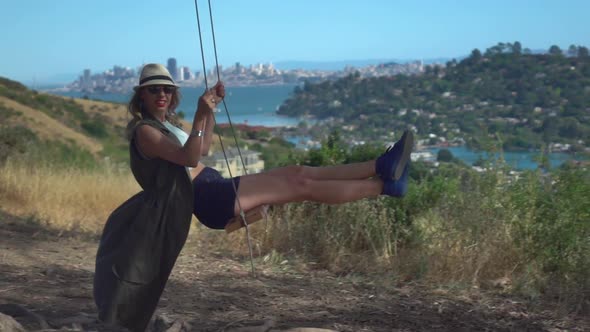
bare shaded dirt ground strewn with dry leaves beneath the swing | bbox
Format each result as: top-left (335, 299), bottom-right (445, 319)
top-left (0, 212), bottom-right (590, 332)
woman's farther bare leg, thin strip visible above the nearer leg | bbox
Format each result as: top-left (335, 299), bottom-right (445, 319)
top-left (264, 160), bottom-right (375, 180)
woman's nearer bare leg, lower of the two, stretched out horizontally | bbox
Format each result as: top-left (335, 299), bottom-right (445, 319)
top-left (235, 170), bottom-right (383, 214)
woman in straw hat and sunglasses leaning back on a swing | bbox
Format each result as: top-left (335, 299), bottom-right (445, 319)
top-left (94, 64), bottom-right (413, 331)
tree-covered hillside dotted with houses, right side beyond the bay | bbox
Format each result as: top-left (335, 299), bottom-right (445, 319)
top-left (279, 42), bottom-right (590, 151)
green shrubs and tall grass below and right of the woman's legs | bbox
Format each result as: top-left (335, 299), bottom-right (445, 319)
top-left (256, 139), bottom-right (590, 303)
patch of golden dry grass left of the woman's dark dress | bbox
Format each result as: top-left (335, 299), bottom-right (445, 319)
top-left (0, 160), bottom-right (140, 232)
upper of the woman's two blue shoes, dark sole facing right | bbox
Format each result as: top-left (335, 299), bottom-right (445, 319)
top-left (375, 130), bottom-right (414, 182)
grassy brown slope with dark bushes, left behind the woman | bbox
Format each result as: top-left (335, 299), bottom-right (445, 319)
top-left (0, 77), bottom-right (189, 166)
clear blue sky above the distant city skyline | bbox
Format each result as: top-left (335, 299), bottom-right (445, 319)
top-left (0, 0), bottom-right (590, 83)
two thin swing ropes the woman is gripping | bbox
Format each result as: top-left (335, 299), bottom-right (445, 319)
top-left (195, 0), bottom-right (256, 276)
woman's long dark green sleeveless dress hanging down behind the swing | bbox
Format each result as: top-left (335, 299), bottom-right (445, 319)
top-left (94, 119), bottom-right (193, 331)
